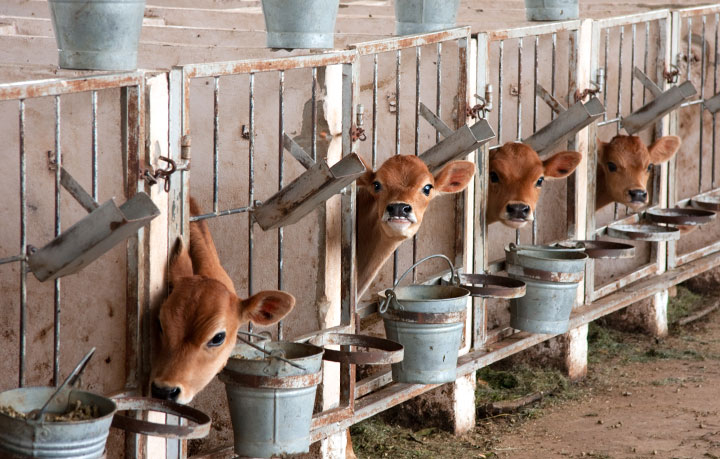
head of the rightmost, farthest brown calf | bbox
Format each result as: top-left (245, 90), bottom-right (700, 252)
top-left (596, 135), bottom-right (681, 210)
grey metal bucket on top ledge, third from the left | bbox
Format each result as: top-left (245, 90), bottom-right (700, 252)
top-left (395, 0), bottom-right (460, 35)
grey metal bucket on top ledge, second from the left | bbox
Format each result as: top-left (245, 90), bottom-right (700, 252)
top-left (262, 0), bottom-right (340, 48)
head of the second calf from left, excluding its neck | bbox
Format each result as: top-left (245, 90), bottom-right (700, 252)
top-left (357, 155), bottom-right (475, 240)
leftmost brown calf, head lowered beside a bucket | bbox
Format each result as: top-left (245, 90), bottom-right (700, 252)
top-left (151, 199), bottom-right (295, 403)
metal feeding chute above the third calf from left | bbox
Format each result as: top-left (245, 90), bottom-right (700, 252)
top-left (523, 85), bottom-right (605, 155)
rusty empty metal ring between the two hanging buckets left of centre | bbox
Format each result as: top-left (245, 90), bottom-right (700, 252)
top-left (323, 333), bottom-right (404, 365)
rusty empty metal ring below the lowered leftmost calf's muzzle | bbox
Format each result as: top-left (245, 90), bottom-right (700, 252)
top-left (112, 397), bottom-right (211, 439)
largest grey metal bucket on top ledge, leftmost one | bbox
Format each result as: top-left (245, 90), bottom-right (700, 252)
top-left (49, 0), bottom-right (145, 70)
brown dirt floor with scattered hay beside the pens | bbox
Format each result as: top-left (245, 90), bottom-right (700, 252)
top-left (352, 287), bottom-right (720, 459)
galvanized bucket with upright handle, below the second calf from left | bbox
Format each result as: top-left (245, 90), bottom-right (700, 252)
top-left (380, 255), bottom-right (470, 384)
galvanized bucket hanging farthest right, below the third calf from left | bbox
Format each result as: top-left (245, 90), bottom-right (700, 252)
top-left (505, 244), bottom-right (588, 334)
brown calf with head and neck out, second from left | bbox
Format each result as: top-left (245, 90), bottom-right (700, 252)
top-left (357, 155), bottom-right (475, 298)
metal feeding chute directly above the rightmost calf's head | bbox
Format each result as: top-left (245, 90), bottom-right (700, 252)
top-left (621, 67), bottom-right (697, 135)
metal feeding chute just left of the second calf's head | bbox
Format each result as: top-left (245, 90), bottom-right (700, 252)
top-left (253, 134), bottom-right (367, 231)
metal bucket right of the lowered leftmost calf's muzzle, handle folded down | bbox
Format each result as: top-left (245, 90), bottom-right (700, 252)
top-left (220, 342), bottom-right (323, 457)
